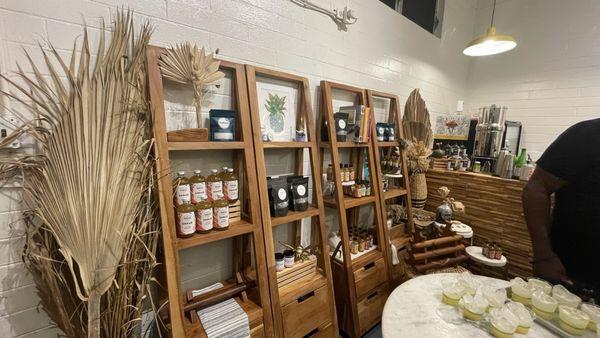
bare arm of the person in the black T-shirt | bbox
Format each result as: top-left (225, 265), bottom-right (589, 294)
top-left (523, 166), bottom-right (567, 283)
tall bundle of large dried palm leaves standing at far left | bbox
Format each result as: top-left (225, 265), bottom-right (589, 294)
top-left (0, 12), bottom-right (158, 337)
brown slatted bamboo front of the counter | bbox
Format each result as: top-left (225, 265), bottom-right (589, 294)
top-left (425, 169), bottom-right (533, 277)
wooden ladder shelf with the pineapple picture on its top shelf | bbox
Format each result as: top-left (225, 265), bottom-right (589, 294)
top-left (246, 65), bottom-right (338, 337)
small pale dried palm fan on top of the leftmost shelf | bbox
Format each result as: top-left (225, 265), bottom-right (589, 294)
top-left (159, 42), bottom-right (225, 128)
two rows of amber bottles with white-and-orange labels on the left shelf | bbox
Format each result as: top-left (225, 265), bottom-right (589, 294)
top-left (173, 167), bottom-right (239, 238)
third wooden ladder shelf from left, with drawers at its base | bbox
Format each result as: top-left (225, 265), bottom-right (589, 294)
top-left (317, 81), bottom-right (389, 337)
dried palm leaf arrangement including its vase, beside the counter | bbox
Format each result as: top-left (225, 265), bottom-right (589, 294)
top-left (402, 89), bottom-right (433, 209)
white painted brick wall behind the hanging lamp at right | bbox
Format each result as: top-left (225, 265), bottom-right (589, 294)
top-left (467, 0), bottom-right (600, 160)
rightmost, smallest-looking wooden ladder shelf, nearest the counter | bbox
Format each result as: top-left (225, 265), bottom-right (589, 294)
top-left (367, 90), bottom-right (414, 285)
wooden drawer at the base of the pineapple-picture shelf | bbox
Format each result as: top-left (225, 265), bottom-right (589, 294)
top-left (283, 285), bottom-right (331, 338)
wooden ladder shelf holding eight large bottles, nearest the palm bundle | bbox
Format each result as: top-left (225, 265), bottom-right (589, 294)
top-left (147, 47), bottom-right (274, 337)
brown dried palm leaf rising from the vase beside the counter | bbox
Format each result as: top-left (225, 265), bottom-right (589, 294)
top-left (402, 89), bottom-right (433, 149)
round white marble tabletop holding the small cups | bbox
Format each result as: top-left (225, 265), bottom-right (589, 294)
top-left (381, 273), bottom-right (557, 338)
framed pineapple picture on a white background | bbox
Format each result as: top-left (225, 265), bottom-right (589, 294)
top-left (256, 82), bottom-right (297, 142)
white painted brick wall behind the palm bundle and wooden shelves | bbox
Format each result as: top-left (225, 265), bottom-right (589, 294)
top-left (0, 0), bottom-right (476, 337)
